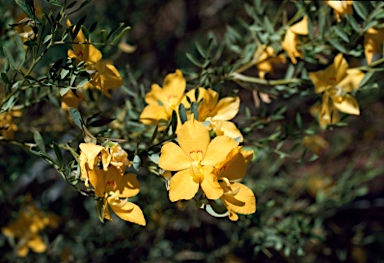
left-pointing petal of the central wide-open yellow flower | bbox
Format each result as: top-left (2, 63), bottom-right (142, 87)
top-left (159, 142), bottom-right (192, 171)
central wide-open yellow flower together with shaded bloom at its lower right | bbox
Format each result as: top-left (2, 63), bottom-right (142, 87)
top-left (159, 118), bottom-right (256, 221)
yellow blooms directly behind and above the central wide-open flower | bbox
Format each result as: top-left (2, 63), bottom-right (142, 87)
top-left (140, 70), bottom-right (243, 141)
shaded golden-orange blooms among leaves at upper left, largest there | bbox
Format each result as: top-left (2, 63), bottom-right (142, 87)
top-left (67, 20), bottom-right (123, 97)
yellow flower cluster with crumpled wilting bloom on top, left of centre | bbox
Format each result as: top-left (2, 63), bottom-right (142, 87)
top-left (79, 142), bottom-right (146, 225)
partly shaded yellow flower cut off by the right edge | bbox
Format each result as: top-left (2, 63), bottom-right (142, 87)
top-left (364, 27), bottom-right (384, 64)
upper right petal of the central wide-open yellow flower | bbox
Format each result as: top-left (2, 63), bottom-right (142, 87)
top-left (201, 136), bottom-right (238, 166)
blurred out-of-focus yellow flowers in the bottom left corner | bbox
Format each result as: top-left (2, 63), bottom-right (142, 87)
top-left (1, 196), bottom-right (59, 257)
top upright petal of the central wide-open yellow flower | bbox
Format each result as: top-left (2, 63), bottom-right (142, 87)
top-left (177, 119), bottom-right (210, 160)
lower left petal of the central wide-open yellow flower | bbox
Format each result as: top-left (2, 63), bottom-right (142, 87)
top-left (169, 169), bottom-right (199, 202)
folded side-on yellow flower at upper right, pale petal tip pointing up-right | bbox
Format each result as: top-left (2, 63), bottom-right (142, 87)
top-left (281, 16), bottom-right (308, 64)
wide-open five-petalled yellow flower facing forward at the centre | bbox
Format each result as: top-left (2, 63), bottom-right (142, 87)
top-left (159, 117), bottom-right (237, 202)
